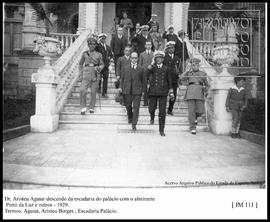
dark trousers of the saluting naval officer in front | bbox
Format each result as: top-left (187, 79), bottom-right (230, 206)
top-left (148, 96), bottom-right (167, 132)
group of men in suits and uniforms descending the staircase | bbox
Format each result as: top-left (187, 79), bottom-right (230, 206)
top-left (80, 21), bottom-right (208, 136)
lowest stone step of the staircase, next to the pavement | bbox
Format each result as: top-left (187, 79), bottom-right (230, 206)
top-left (59, 120), bottom-right (209, 134)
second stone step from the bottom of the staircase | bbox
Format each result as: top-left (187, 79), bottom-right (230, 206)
top-left (60, 112), bottom-right (205, 125)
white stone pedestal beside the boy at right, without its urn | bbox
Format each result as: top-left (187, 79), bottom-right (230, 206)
top-left (209, 67), bottom-right (233, 135)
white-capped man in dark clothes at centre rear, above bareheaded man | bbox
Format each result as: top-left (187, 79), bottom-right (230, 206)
top-left (132, 25), bottom-right (155, 55)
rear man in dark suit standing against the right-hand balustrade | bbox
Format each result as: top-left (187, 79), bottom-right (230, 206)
top-left (175, 30), bottom-right (189, 73)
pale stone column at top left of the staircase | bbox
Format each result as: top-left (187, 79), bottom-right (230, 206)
top-left (77, 3), bottom-right (99, 34)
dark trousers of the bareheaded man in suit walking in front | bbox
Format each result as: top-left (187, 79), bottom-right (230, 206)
top-left (123, 94), bottom-right (142, 125)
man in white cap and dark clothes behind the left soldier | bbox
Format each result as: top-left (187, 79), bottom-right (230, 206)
top-left (96, 33), bottom-right (113, 97)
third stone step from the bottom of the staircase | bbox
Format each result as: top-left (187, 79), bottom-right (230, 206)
top-left (63, 104), bottom-right (188, 114)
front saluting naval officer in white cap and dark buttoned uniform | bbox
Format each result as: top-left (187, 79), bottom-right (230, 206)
top-left (148, 51), bottom-right (173, 136)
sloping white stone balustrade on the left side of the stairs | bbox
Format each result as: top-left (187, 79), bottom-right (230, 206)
top-left (53, 31), bottom-right (91, 113)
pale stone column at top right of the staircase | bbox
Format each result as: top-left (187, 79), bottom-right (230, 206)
top-left (171, 3), bottom-right (189, 33)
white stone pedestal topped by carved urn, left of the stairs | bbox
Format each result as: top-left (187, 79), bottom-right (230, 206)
top-left (30, 38), bottom-right (61, 133)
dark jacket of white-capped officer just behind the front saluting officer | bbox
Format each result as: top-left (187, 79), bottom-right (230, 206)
top-left (163, 53), bottom-right (181, 84)
